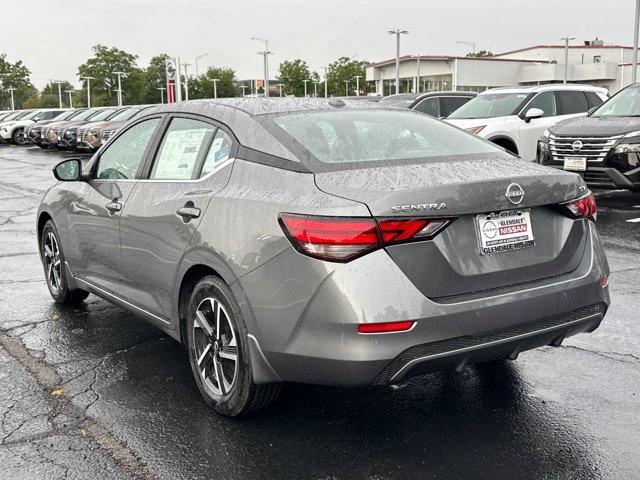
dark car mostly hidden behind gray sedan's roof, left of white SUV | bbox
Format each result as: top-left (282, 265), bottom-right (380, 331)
top-left (380, 92), bottom-right (476, 118)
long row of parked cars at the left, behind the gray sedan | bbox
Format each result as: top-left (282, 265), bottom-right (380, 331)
top-left (0, 105), bottom-right (148, 151)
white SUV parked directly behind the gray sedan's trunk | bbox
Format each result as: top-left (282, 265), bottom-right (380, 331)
top-left (446, 84), bottom-right (607, 160)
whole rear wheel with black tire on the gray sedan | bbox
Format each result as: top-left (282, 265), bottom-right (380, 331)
top-left (186, 275), bottom-right (281, 417)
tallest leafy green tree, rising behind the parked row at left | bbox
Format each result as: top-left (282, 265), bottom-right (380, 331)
top-left (78, 45), bottom-right (146, 106)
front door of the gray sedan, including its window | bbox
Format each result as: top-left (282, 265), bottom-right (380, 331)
top-left (68, 118), bottom-right (160, 299)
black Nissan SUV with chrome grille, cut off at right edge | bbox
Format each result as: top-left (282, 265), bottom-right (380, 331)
top-left (536, 83), bottom-right (640, 191)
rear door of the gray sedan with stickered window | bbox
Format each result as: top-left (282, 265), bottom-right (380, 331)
top-left (120, 114), bottom-right (237, 321)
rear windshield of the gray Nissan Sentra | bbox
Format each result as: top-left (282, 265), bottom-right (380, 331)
top-left (273, 110), bottom-right (502, 164)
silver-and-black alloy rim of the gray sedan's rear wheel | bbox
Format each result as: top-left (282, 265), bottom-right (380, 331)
top-left (193, 297), bottom-right (238, 396)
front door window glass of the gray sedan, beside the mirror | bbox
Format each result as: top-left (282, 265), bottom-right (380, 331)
top-left (95, 118), bottom-right (160, 180)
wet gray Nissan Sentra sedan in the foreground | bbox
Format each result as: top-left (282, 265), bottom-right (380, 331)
top-left (37, 99), bottom-right (610, 415)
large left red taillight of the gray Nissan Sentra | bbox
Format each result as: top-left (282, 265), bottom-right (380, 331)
top-left (278, 213), bottom-right (451, 262)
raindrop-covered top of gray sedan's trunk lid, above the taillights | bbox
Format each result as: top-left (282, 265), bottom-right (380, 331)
top-left (315, 154), bottom-right (586, 216)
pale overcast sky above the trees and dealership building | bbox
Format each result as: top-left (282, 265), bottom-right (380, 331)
top-left (0, 0), bottom-right (635, 87)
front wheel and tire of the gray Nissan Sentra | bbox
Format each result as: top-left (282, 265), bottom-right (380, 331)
top-left (40, 220), bottom-right (89, 305)
